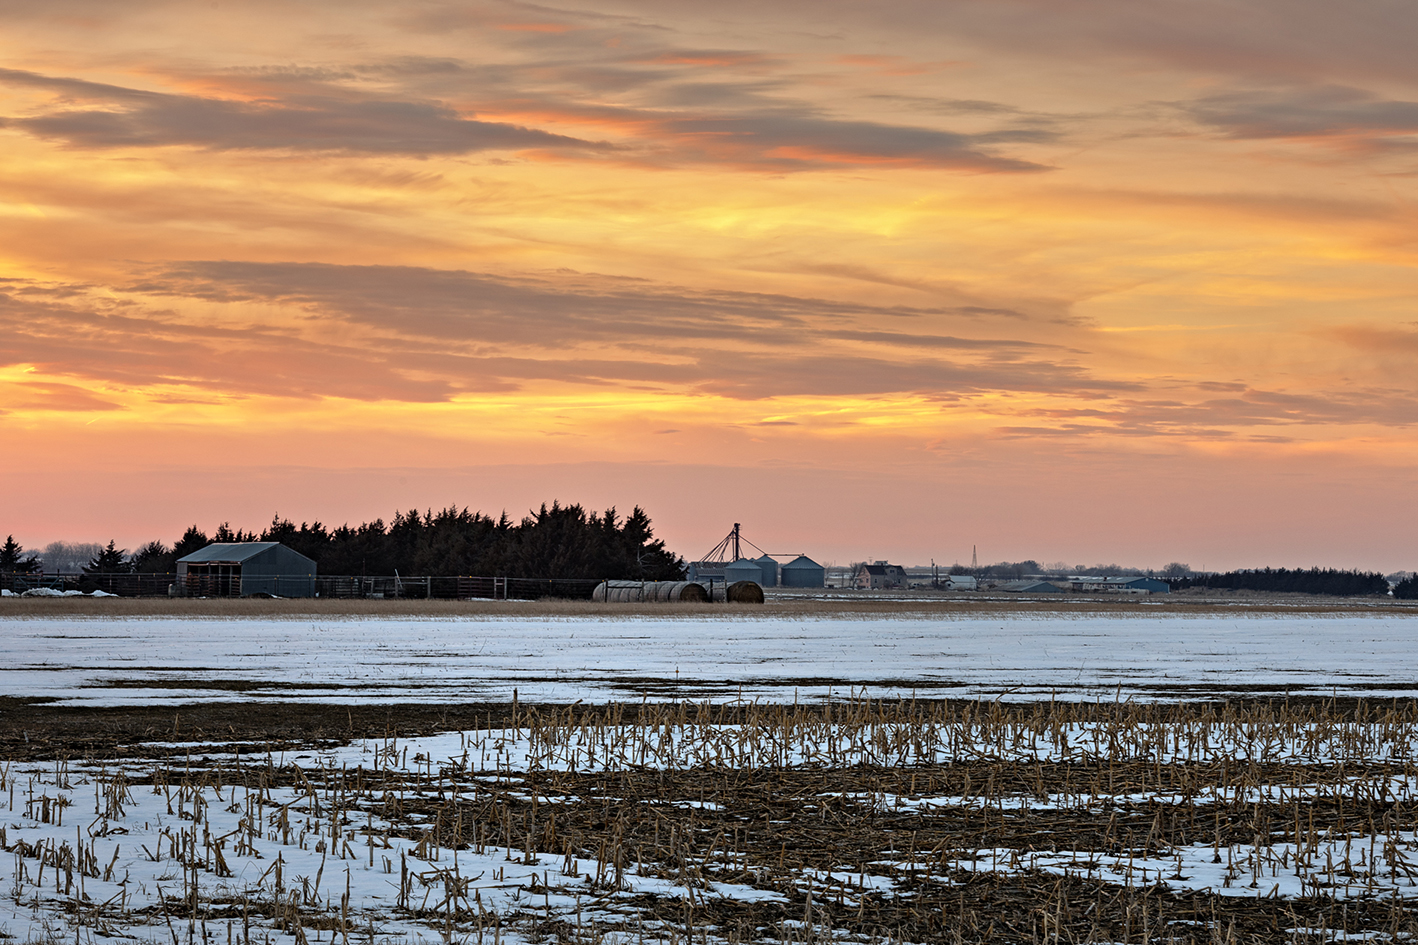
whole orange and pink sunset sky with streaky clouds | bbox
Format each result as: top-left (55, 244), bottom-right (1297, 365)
top-left (0, 0), bottom-right (1418, 570)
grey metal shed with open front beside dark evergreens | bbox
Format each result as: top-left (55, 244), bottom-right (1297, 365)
top-left (174, 542), bottom-right (315, 597)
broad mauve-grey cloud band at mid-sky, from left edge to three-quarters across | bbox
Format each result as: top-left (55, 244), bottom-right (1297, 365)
top-left (0, 263), bottom-right (1136, 402)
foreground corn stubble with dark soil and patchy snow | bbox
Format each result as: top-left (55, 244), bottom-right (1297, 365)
top-left (8, 695), bottom-right (1418, 945)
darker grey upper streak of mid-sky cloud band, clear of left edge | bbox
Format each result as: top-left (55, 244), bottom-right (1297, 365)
top-left (135, 261), bottom-right (1054, 350)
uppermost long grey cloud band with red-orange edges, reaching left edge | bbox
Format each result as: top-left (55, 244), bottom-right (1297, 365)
top-left (0, 59), bottom-right (1055, 173)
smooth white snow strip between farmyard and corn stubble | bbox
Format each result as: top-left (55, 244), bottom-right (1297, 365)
top-left (0, 612), bottom-right (1418, 705)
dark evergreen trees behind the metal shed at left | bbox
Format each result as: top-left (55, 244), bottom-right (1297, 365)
top-left (0, 502), bottom-right (685, 580)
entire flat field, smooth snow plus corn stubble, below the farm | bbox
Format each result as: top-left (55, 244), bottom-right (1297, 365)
top-left (0, 600), bottom-right (1418, 945)
